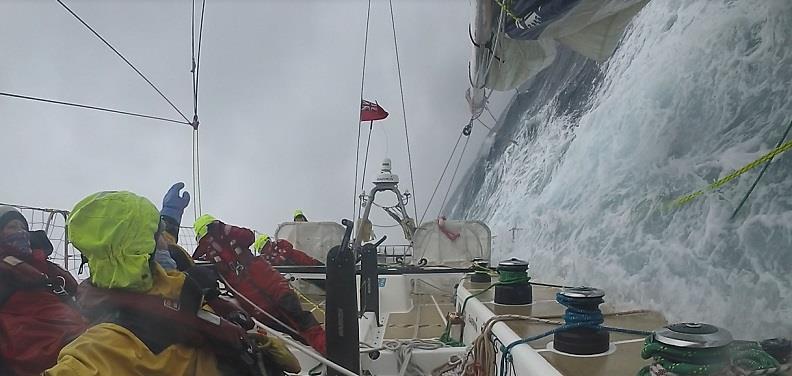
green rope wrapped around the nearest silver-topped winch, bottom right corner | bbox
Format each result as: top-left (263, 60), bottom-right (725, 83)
top-left (638, 336), bottom-right (778, 376)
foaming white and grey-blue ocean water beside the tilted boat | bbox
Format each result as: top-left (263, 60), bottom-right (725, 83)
top-left (453, 0), bottom-right (792, 339)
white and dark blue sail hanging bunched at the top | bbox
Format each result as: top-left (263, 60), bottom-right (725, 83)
top-left (467, 0), bottom-right (649, 113)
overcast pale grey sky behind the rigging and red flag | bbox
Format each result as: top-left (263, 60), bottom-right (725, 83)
top-left (0, 0), bottom-right (506, 235)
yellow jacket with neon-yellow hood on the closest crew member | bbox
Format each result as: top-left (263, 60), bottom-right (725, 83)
top-left (44, 192), bottom-right (221, 376)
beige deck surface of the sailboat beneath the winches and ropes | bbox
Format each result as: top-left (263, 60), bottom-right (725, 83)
top-left (290, 276), bottom-right (667, 376)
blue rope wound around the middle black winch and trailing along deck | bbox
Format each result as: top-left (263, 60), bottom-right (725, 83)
top-left (500, 293), bottom-right (652, 376)
